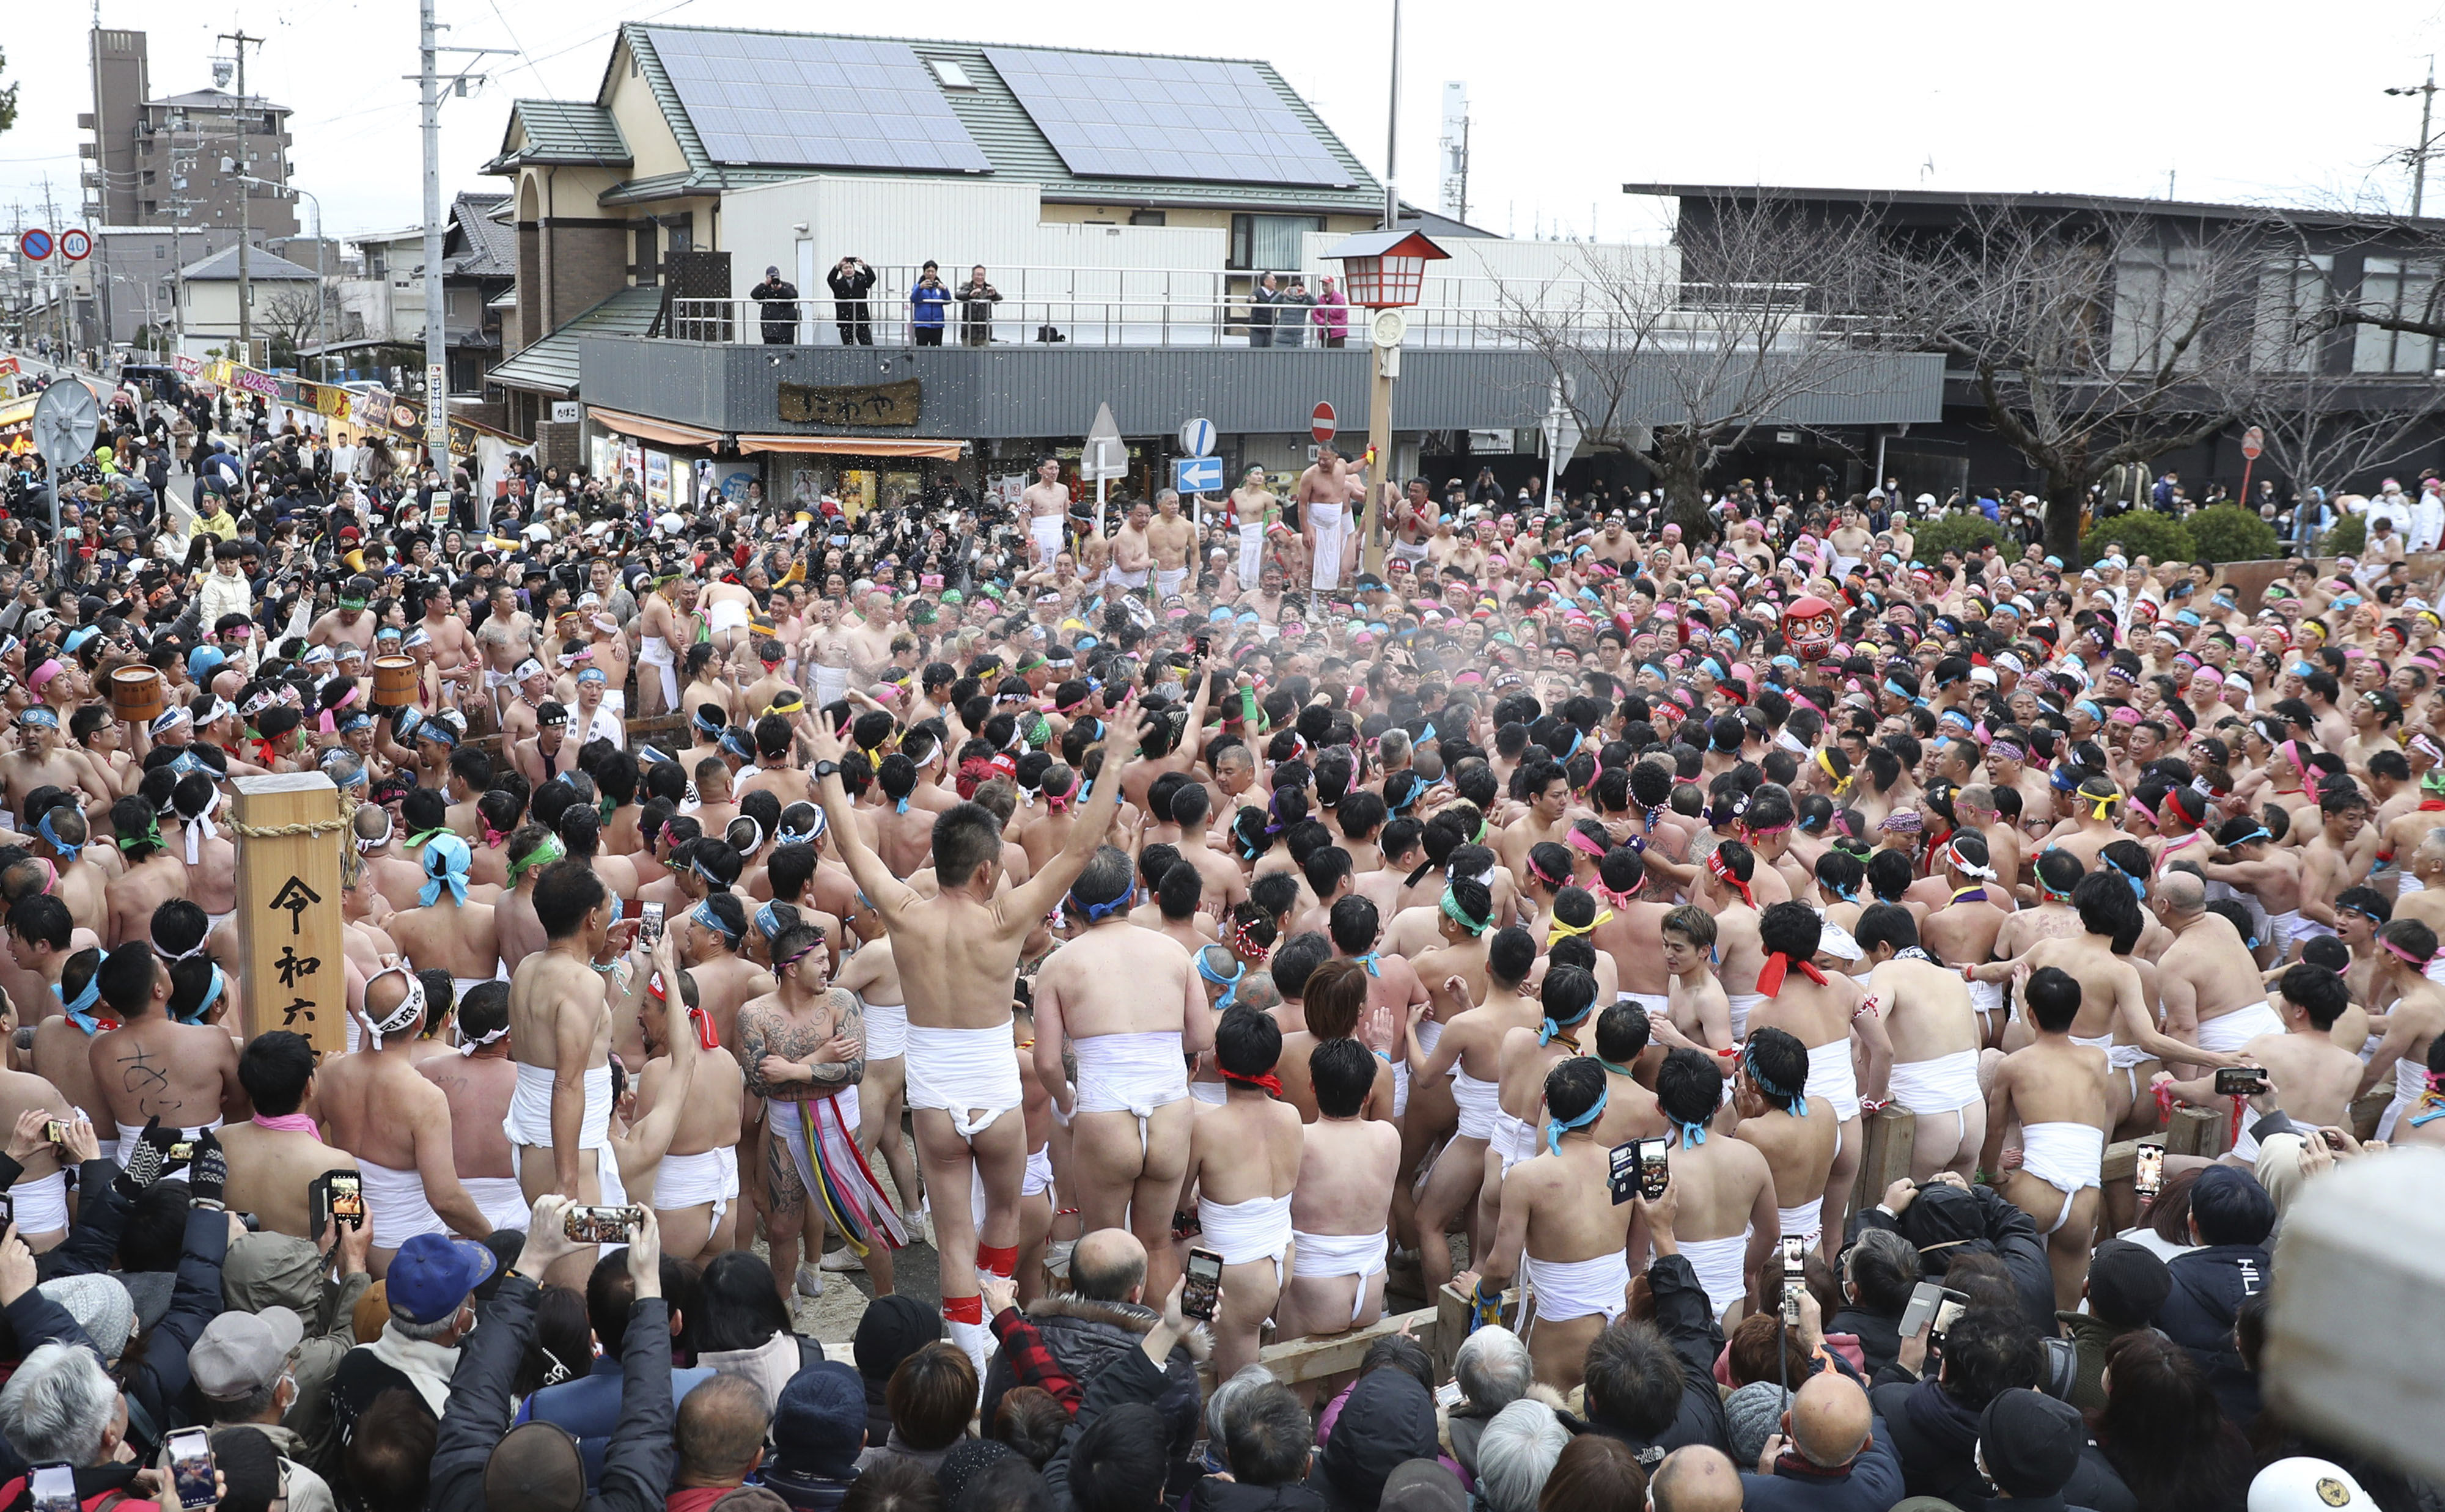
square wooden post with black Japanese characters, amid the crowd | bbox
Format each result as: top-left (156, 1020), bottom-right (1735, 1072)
top-left (230, 771), bottom-right (347, 1052)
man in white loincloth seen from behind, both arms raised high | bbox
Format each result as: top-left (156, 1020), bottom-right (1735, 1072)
top-left (809, 697), bottom-right (1137, 1360)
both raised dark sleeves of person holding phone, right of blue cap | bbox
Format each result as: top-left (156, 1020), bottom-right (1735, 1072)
top-left (425, 1277), bottom-right (677, 1512)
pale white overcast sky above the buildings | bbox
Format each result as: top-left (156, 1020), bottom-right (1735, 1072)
top-left (0, 0), bottom-right (2445, 240)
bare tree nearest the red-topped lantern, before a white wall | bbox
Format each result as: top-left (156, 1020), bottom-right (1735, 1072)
top-left (1499, 193), bottom-right (1907, 536)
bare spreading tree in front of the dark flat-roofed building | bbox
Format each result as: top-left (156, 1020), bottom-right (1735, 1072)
top-left (1875, 203), bottom-right (2257, 560)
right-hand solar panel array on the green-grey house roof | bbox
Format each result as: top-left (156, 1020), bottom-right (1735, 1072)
top-left (985, 46), bottom-right (1352, 188)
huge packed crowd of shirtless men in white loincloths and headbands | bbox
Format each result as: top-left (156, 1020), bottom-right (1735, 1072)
top-left (0, 458), bottom-right (2445, 1387)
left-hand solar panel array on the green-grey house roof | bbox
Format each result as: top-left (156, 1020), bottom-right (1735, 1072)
top-left (645, 27), bottom-right (993, 174)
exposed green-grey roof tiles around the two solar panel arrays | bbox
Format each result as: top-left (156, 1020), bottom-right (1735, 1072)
top-left (501, 22), bottom-right (1384, 215)
